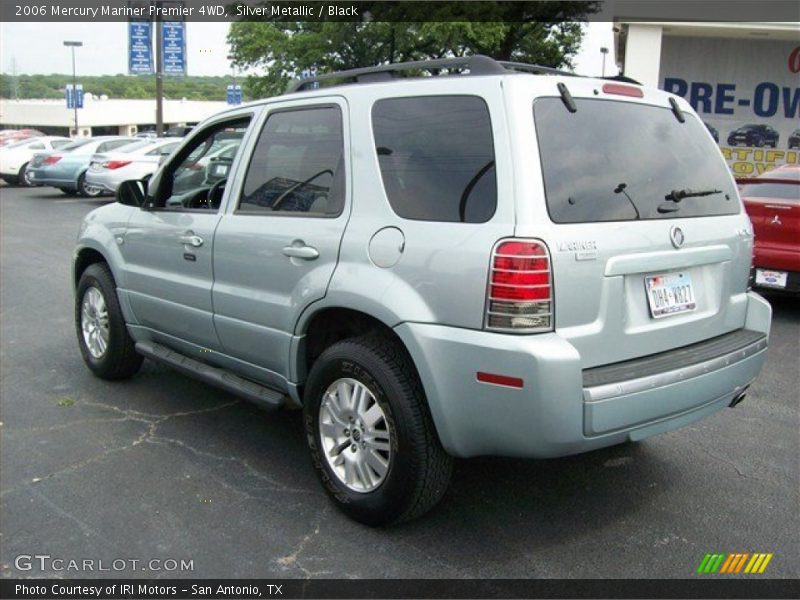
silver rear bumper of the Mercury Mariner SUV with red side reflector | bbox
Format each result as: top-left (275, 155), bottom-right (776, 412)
top-left (396, 293), bottom-right (771, 458)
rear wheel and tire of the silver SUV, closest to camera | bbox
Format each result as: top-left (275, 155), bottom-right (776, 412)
top-left (303, 335), bottom-right (453, 526)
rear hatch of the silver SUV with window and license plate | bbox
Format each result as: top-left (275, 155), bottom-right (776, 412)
top-left (517, 80), bottom-right (752, 368)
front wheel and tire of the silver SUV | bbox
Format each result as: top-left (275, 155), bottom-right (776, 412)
top-left (75, 263), bottom-right (143, 380)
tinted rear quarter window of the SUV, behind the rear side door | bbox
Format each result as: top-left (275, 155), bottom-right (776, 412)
top-left (372, 96), bottom-right (497, 223)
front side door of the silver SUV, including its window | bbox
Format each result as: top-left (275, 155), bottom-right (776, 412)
top-left (120, 114), bottom-right (250, 350)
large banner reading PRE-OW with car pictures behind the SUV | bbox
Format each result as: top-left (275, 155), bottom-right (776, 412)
top-left (660, 35), bottom-right (800, 177)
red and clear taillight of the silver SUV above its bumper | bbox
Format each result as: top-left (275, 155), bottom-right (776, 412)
top-left (486, 240), bottom-right (553, 333)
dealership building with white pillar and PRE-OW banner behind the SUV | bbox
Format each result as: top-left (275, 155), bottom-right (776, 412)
top-left (615, 16), bottom-right (800, 177)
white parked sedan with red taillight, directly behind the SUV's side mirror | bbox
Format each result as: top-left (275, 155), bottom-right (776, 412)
top-left (86, 138), bottom-right (183, 193)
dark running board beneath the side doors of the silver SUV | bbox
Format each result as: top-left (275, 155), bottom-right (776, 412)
top-left (136, 342), bottom-right (286, 410)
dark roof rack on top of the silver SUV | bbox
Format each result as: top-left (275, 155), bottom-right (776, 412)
top-left (284, 54), bottom-right (577, 94)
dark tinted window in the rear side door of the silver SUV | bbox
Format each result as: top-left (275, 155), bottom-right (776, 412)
top-left (239, 106), bottom-right (345, 216)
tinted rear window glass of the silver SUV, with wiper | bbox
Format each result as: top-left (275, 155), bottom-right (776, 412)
top-left (533, 98), bottom-right (740, 223)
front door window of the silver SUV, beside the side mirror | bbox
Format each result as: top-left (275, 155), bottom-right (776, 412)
top-left (155, 116), bottom-right (250, 210)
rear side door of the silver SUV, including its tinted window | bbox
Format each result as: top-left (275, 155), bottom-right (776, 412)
top-left (213, 97), bottom-right (350, 378)
